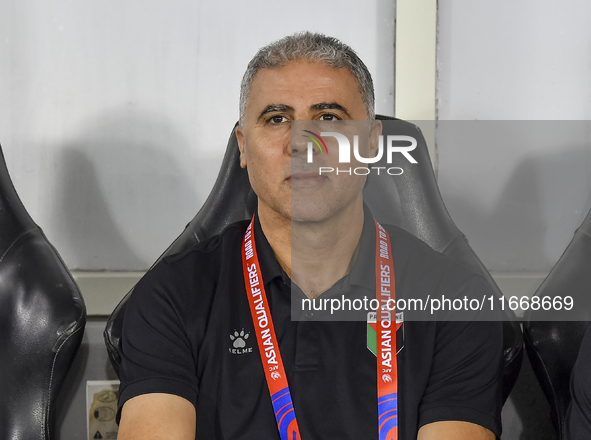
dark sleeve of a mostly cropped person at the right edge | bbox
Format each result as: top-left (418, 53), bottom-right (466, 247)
top-left (565, 327), bottom-right (591, 440)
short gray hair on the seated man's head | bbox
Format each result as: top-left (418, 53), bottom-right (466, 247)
top-left (240, 32), bottom-right (375, 125)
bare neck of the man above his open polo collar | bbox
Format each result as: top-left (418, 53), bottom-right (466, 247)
top-left (259, 197), bottom-right (364, 298)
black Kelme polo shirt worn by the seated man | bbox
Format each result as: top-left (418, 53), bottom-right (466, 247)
top-left (119, 212), bottom-right (502, 440)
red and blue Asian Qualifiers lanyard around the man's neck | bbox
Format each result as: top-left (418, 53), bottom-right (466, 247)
top-left (242, 216), bottom-right (398, 440)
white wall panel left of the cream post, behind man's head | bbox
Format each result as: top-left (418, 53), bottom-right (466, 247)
top-left (0, 0), bottom-right (395, 270)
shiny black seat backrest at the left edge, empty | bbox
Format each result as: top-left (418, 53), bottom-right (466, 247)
top-left (0, 148), bottom-right (86, 440)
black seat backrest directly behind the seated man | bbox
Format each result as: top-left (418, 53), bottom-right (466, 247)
top-left (105, 115), bottom-right (523, 398)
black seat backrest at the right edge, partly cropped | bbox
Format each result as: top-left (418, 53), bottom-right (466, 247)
top-left (523, 211), bottom-right (591, 439)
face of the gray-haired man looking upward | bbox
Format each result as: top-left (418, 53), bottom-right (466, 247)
top-left (236, 60), bottom-right (381, 221)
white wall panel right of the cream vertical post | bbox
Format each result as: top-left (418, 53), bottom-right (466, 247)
top-left (438, 0), bottom-right (591, 272)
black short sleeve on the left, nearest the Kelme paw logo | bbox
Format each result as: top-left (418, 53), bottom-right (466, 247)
top-left (117, 261), bottom-right (199, 420)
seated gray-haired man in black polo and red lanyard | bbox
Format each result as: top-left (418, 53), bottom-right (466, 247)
top-left (119, 33), bottom-right (502, 440)
